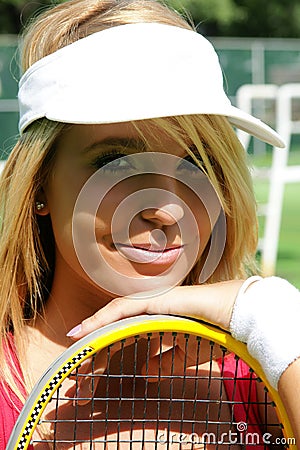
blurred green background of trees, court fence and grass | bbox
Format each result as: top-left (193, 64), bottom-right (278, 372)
top-left (0, 0), bottom-right (300, 288)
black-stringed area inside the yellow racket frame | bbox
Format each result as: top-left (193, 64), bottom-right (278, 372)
top-left (33, 333), bottom-right (279, 450)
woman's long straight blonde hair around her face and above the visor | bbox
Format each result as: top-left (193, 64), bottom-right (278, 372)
top-left (0, 0), bottom-right (257, 400)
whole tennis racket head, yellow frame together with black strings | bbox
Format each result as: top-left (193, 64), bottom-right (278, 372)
top-left (7, 315), bottom-right (296, 450)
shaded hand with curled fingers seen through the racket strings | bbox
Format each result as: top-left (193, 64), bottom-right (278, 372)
top-left (69, 332), bottom-right (218, 406)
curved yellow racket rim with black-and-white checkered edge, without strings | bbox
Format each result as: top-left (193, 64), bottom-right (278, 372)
top-left (6, 315), bottom-right (297, 450)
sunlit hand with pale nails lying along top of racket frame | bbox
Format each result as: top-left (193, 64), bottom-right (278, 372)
top-left (67, 280), bottom-right (243, 340)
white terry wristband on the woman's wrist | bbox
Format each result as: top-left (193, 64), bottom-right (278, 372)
top-left (230, 277), bottom-right (300, 389)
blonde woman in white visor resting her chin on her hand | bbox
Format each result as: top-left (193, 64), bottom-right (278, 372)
top-left (0, 0), bottom-right (300, 449)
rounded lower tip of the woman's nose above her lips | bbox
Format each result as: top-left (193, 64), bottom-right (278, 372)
top-left (141, 203), bottom-right (184, 226)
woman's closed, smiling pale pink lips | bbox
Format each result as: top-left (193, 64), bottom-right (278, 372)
top-left (115, 243), bottom-right (184, 265)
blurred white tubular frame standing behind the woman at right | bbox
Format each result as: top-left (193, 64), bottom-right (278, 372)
top-left (237, 83), bottom-right (300, 275)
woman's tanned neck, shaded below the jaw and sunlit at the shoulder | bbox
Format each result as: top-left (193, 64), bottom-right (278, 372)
top-left (18, 253), bottom-right (112, 387)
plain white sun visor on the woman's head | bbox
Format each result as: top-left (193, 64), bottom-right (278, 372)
top-left (19, 23), bottom-right (284, 147)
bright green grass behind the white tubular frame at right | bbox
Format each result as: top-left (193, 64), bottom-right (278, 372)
top-left (251, 149), bottom-right (300, 289)
